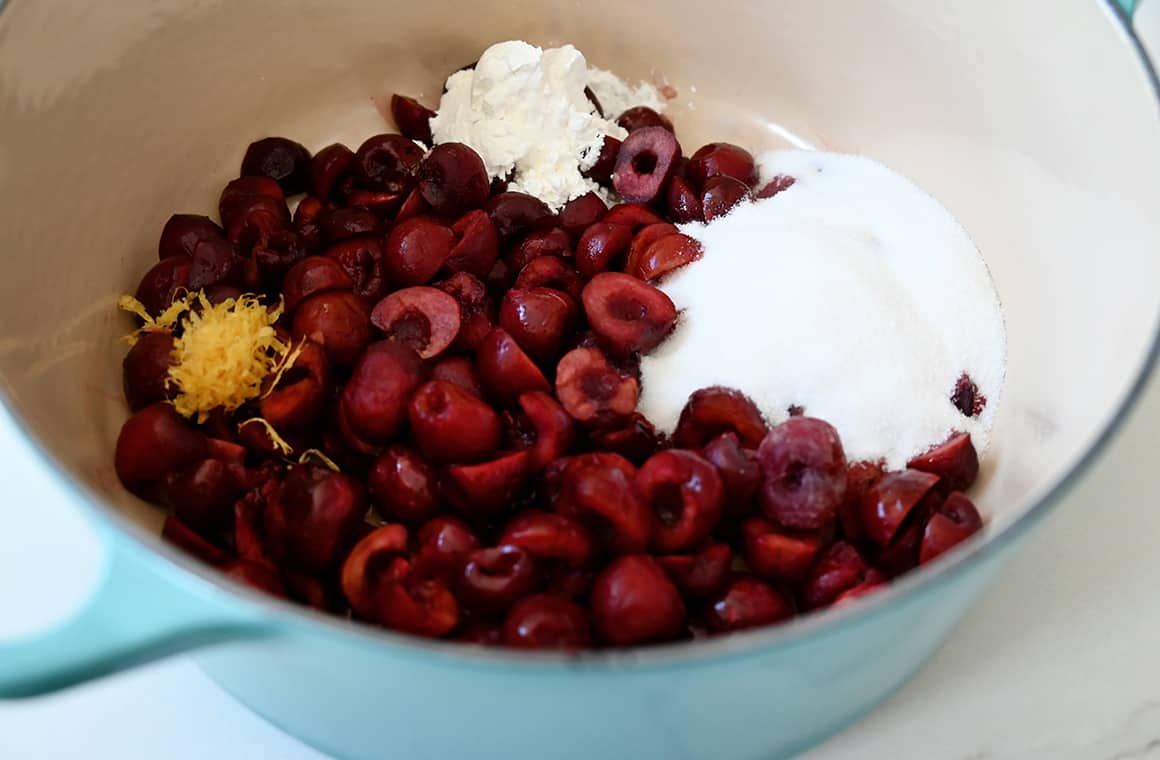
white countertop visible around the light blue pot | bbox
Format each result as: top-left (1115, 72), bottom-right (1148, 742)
top-left (0, 7), bottom-right (1160, 760)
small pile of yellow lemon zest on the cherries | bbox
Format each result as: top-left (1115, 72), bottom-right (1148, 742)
top-left (117, 291), bottom-right (302, 424)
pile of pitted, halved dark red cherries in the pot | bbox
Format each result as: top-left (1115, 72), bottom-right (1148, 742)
top-left (116, 87), bottom-right (981, 649)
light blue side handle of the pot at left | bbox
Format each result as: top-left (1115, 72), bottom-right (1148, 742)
top-left (0, 536), bottom-right (274, 700)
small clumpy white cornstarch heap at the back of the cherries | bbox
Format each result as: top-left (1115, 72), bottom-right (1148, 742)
top-left (430, 41), bottom-right (660, 209)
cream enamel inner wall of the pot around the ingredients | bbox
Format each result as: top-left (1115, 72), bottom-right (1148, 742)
top-left (0, 0), bottom-right (1160, 547)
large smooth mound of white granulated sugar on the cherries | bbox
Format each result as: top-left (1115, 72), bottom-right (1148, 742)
top-left (639, 151), bottom-right (1006, 468)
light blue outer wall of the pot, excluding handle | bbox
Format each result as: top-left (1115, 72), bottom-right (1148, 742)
top-left (196, 555), bottom-right (1006, 760)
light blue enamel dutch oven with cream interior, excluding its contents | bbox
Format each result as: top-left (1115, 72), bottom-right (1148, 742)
top-left (0, 0), bottom-right (1160, 760)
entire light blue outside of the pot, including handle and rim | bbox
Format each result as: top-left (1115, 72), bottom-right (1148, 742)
top-left (0, 0), bottom-right (1157, 760)
